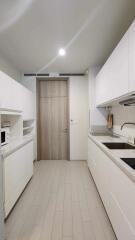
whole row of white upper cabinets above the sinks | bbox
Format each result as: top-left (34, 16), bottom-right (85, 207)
top-left (96, 21), bottom-right (135, 106)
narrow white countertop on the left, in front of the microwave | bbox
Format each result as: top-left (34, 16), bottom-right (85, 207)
top-left (1, 135), bottom-right (33, 158)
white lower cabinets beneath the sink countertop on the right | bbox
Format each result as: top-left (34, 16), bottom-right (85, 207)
top-left (88, 139), bottom-right (135, 240)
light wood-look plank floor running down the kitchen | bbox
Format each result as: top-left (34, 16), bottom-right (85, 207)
top-left (6, 161), bottom-right (116, 240)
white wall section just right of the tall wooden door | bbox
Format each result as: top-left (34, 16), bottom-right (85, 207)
top-left (69, 77), bottom-right (88, 160)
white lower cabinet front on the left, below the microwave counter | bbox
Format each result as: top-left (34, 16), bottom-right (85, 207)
top-left (4, 141), bottom-right (33, 217)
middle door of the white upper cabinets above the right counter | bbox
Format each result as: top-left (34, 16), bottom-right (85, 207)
top-left (108, 31), bottom-right (129, 99)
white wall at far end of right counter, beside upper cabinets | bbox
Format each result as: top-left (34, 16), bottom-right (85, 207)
top-left (88, 67), bottom-right (107, 131)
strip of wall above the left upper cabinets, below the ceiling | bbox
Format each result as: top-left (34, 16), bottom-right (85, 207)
top-left (0, 55), bottom-right (21, 81)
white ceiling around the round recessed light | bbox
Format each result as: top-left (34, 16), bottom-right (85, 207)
top-left (0, 0), bottom-right (135, 73)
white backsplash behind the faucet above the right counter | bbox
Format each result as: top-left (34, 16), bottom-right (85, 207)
top-left (112, 105), bottom-right (135, 142)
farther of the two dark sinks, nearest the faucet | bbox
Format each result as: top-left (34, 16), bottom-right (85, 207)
top-left (103, 142), bottom-right (135, 149)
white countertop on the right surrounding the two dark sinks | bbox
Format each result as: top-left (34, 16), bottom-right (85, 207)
top-left (89, 134), bottom-right (135, 182)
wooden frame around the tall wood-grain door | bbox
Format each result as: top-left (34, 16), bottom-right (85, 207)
top-left (36, 77), bottom-right (70, 161)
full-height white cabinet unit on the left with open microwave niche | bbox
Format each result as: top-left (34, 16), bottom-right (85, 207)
top-left (0, 71), bottom-right (34, 219)
